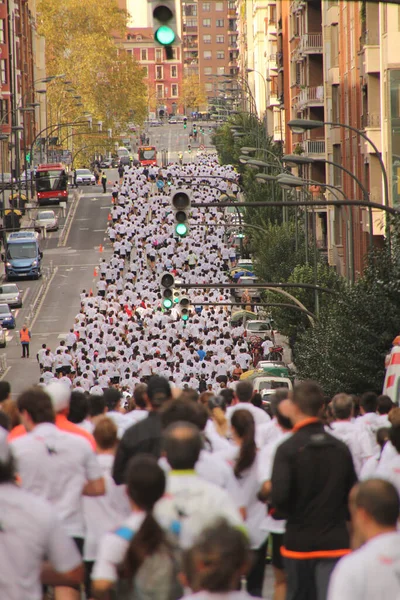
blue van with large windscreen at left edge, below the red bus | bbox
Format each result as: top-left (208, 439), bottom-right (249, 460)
top-left (1, 231), bottom-right (43, 281)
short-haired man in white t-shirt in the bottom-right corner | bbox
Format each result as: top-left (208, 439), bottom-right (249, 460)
top-left (328, 479), bottom-right (400, 600)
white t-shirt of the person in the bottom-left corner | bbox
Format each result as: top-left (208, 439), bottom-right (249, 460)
top-left (0, 483), bottom-right (81, 600)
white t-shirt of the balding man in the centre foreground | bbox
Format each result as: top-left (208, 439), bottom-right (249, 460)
top-left (154, 471), bottom-right (243, 548)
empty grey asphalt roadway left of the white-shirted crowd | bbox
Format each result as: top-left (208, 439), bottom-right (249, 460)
top-left (0, 169), bottom-right (118, 396)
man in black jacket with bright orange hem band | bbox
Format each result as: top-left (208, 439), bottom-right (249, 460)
top-left (271, 381), bottom-right (357, 600)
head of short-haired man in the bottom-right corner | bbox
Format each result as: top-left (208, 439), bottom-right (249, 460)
top-left (349, 479), bottom-right (400, 543)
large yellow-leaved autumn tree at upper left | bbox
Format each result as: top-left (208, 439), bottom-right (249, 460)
top-left (38, 0), bottom-right (146, 131)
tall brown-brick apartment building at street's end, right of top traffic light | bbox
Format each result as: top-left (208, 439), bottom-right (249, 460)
top-left (181, 0), bottom-right (238, 108)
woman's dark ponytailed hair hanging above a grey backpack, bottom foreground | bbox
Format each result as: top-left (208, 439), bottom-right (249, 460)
top-left (124, 454), bottom-right (168, 577)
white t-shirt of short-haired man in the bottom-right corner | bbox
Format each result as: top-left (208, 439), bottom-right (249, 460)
top-left (328, 532), bottom-right (400, 600)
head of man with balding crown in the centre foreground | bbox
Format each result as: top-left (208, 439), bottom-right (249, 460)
top-left (163, 421), bottom-right (203, 471)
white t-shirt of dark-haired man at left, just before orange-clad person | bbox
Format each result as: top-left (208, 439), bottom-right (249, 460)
top-left (11, 423), bottom-right (102, 537)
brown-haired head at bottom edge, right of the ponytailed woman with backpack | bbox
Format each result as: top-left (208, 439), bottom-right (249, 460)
top-left (183, 519), bottom-right (251, 593)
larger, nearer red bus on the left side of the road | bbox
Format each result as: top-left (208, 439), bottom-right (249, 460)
top-left (35, 163), bottom-right (68, 206)
